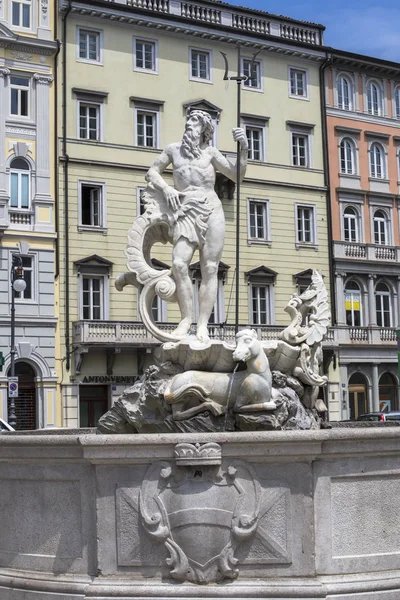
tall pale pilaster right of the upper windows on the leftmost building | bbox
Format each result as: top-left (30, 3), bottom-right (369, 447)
top-left (33, 74), bottom-right (53, 200)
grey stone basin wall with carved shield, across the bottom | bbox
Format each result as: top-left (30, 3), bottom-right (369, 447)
top-left (0, 427), bottom-right (400, 600)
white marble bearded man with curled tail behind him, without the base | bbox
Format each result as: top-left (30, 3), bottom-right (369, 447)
top-left (116, 110), bottom-right (248, 343)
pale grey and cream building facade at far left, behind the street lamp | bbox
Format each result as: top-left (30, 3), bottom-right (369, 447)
top-left (0, 0), bottom-right (61, 429)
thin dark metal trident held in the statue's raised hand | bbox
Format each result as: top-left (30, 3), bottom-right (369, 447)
top-left (221, 48), bottom-right (261, 333)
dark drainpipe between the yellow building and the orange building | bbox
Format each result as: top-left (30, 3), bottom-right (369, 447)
top-left (319, 52), bottom-right (336, 325)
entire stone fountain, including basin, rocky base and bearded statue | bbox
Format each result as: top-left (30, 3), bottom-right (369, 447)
top-left (0, 111), bottom-right (400, 600)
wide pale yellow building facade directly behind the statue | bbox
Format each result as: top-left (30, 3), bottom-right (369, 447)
top-left (58, 0), bottom-right (330, 426)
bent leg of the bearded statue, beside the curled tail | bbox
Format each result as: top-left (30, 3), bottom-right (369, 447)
top-left (172, 238), bottom-right (196, 339)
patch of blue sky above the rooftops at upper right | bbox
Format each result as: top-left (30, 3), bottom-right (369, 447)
top-left (228, 0), bottom-right (400, 62)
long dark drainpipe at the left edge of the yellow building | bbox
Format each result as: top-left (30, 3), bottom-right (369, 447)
top-left (62, 0), bottom-right (72, 371)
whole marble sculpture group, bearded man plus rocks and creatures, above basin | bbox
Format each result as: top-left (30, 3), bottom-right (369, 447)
top-left (103, 110), bottom-right (330, 433)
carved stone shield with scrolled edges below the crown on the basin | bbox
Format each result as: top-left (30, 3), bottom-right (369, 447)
top-left (139, 454), bottom-right (260, 583)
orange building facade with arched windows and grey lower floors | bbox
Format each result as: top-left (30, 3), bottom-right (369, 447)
top-left (325, 51), bottom-right (400, 419)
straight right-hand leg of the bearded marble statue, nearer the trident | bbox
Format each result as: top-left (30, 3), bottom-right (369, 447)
top-left (196, 207), bottom-right (225, 342)
